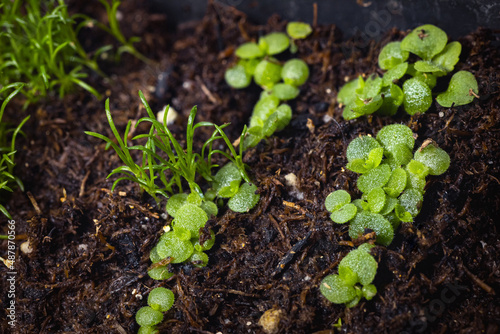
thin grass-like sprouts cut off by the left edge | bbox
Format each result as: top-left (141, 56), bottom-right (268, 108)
top-left (0, 83), bottom-right (30, 219)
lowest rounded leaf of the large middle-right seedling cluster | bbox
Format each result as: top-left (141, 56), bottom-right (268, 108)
top-left (349, 211), bottom-right (394, 246)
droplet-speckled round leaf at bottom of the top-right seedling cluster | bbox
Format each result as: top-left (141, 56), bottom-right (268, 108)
top-left (403, 78), bottom-right (432, 115)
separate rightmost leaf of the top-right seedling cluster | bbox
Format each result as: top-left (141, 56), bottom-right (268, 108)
top-left (436, 71), bottom-right (478, 108)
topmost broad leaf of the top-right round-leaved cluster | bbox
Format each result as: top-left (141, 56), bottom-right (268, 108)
top-left (401, 24), bottom-right (448, 60)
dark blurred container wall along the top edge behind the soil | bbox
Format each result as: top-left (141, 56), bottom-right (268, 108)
top-left (152, 0), bottom-right (500, 39)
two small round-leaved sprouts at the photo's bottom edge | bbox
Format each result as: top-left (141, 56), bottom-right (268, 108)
top-left (135, 287), bottom-right (175, 334)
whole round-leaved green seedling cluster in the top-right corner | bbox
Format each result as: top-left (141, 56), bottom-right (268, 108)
top-left (337, 24), bottom-right (478, 120)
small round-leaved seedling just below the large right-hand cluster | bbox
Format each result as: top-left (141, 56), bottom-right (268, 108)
top-left (320, 244), bottom-right (378, 307)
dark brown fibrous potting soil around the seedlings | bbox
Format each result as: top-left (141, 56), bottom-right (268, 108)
top-left (0, 1), bottom-right (500, 334)
